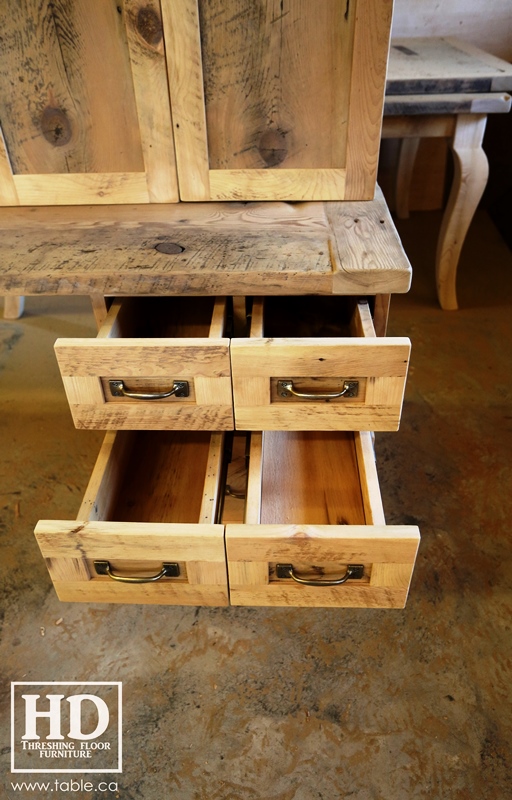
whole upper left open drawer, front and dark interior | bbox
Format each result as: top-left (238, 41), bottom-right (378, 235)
top-left (55, 297), bottom-right (233, 431)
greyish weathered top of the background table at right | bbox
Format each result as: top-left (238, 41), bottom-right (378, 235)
top-left (386, 37), bottom-right (512, 95)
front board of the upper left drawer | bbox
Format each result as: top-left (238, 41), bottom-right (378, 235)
top-left (55, 338), bottom-right (233, 430)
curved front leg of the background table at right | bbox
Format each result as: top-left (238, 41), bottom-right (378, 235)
top-left (436, 114), bottom-right (489, 311)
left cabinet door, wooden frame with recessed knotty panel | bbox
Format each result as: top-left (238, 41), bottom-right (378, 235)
top-left (0, 0), bottom-right (178, 205)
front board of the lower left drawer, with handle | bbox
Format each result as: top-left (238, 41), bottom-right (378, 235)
top-left (35, 520), bottom-right (229, 606)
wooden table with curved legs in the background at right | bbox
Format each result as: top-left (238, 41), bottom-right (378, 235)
top-left (382, 37), bottom-right (512, 310)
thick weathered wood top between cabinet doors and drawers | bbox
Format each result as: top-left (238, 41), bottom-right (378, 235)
top-left (0, 190), bottom-right (411, 295)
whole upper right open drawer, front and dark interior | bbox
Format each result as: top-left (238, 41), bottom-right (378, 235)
top-left (231, 296), bottom-right (411, 431)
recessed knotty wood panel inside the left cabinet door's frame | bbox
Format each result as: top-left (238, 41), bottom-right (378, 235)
top-left (0, 0), bottom-right (143, 175)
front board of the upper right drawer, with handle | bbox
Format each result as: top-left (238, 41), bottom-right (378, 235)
top-left (231, 337), bottom-right (410, 431)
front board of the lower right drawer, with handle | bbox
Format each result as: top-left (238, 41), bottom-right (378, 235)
top-left (226, 525), bottom-right (419, 608)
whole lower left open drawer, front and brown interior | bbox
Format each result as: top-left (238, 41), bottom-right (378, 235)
top-left (35, 431), bottom-right (229, 606)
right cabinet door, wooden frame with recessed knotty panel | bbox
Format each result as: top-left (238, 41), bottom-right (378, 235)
top-left (162, 0), bottom-right (392, 200)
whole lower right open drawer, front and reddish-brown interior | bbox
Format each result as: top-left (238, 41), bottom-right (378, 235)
top-left (226, 431), bottom-right (419, 608)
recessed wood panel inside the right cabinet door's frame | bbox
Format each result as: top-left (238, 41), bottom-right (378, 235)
top-left (199, 0), bottom-right (354, 170)
